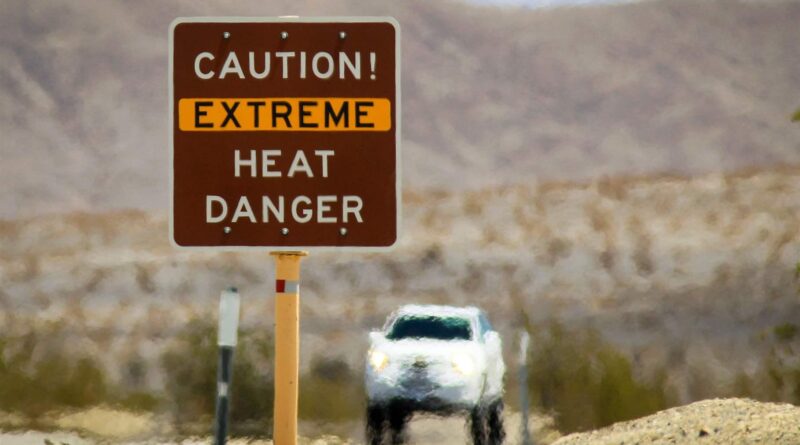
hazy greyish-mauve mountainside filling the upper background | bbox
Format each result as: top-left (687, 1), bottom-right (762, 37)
top-left (0, 0), bottom-right (800, 218)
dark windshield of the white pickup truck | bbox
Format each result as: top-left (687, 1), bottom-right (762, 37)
top-left (386, 315), bottom-right (472, 340)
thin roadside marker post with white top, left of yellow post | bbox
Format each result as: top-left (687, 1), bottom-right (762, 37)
top-left (214, 287), bottom-right (240, 445)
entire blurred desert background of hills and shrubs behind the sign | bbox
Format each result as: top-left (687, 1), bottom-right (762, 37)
top-left (0, 0), bottom-right (800, 442)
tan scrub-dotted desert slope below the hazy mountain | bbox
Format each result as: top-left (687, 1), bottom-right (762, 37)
top-left (0, 170), bottom-right (800, 401)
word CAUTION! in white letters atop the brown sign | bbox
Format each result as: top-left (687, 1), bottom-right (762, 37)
top-left (194, 51), bottom-right (376, 80)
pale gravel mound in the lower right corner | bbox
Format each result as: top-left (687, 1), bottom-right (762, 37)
top-left (554, 399), bottom-right (800, 445)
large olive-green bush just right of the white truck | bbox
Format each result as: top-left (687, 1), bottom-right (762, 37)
top-left (528, 322), bottom-right (669, 432)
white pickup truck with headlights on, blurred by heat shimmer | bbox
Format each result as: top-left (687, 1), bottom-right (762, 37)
top-left (365, 305), bottom-right (505, 445)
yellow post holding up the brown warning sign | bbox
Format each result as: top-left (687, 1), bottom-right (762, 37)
top-left (271, 252), bottom-right (308, 445)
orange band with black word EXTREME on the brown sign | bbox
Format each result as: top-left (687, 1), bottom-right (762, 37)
top-left (178, 97), bottom-right (392, 131)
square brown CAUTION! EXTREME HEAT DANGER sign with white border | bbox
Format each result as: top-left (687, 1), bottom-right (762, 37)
top-left (170, 18), bottom-right (400, 249)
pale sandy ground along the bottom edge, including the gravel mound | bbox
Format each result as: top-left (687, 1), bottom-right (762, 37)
top-left (6, 399), bottom-right (800, 445)
